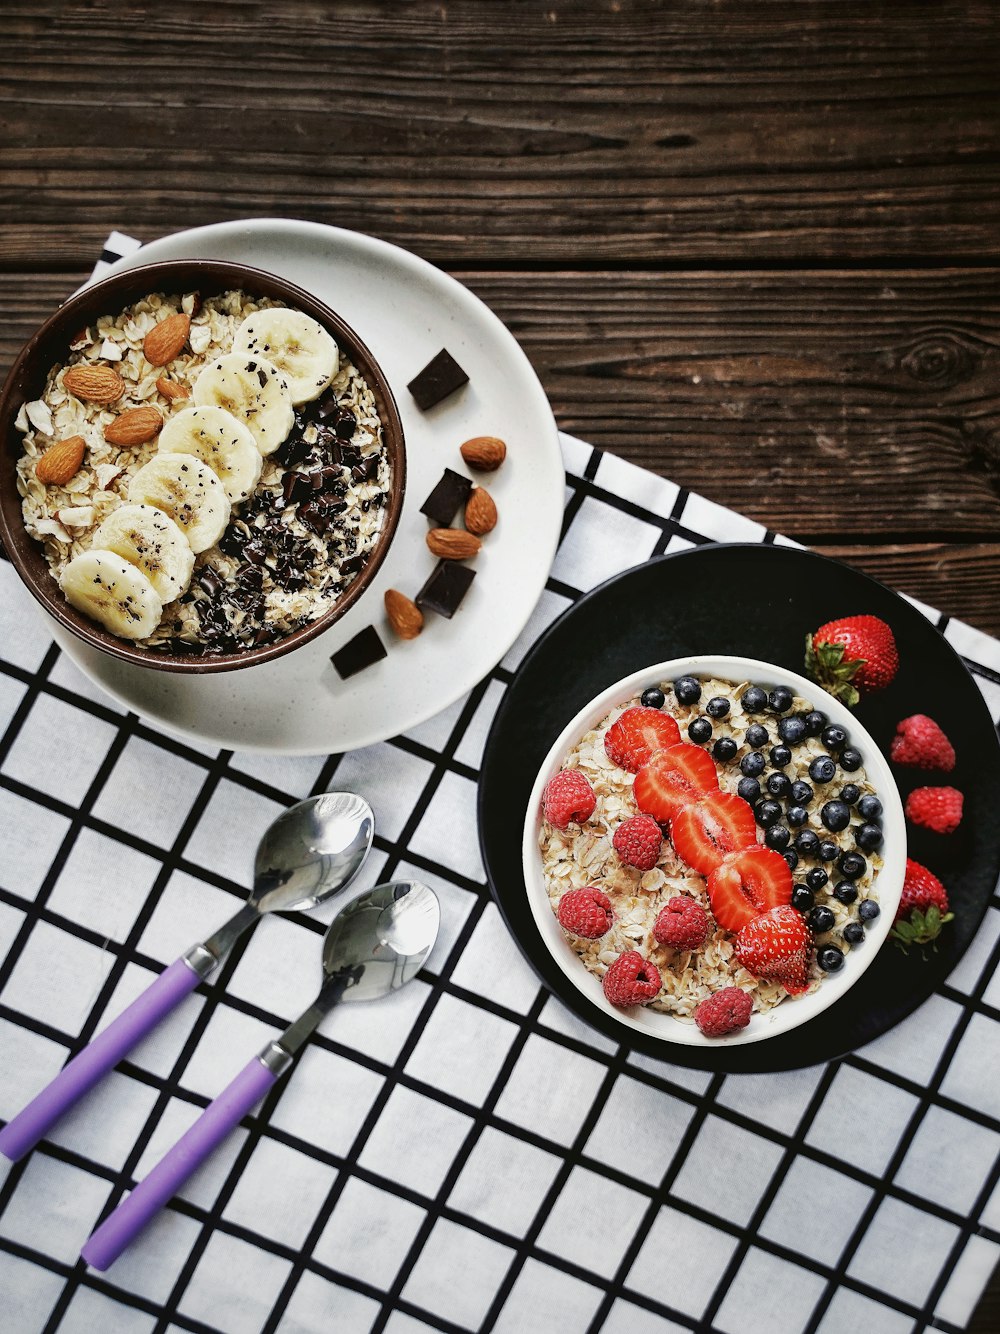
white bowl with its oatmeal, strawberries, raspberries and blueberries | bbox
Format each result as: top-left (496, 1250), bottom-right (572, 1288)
top-left (523, 656), bottom-right (905, 1046)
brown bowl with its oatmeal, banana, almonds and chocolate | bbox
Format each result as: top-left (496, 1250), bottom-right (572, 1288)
top-left (0, 260), bottom-right (405, 672)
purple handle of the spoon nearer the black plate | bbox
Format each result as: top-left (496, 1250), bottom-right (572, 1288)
top-left (80, 1057), bottom-right (277, 1270)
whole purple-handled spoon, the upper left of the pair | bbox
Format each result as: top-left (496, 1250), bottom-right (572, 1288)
top-left (0, 792), bottom-right (375, 1162)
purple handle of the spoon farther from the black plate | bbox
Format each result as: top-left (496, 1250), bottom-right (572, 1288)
top-left (0, 959), bottom-right (201, 1162)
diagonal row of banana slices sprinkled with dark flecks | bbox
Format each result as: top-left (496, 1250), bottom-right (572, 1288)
top-left (60, 307), bottom-right (340, 639)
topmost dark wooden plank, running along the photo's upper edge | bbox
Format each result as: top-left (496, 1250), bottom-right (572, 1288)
top-left (0, 0), bottom-right (1000, 267)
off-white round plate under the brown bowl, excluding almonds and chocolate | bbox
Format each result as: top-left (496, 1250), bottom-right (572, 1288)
top-left (45, 219), bottom-right (564, 755)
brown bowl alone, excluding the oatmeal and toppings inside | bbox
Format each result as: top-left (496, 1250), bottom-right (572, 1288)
top-left (0, 259), bottom-right (407, 672)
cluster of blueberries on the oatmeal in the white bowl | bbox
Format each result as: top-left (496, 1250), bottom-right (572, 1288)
top-left (674, 676), bottom-right (883, 972)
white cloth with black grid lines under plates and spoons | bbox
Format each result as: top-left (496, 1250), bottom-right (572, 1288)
top-left (0, 237), bottom-right (1000, 1334)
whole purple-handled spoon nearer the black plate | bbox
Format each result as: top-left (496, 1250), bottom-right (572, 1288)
top-left (80, 880), bottom-right (440, 1270)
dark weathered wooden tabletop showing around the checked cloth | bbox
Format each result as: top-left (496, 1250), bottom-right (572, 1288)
top-left (0, 0), bottom-right (1000, 1331)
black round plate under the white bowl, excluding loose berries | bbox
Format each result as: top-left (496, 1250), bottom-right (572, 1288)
top-left (479, 543), bottom-right (1000, 1071)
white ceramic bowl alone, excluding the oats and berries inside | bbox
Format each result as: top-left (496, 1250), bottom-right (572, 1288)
top-left (521, 656), bottom-right (907, 1047)
